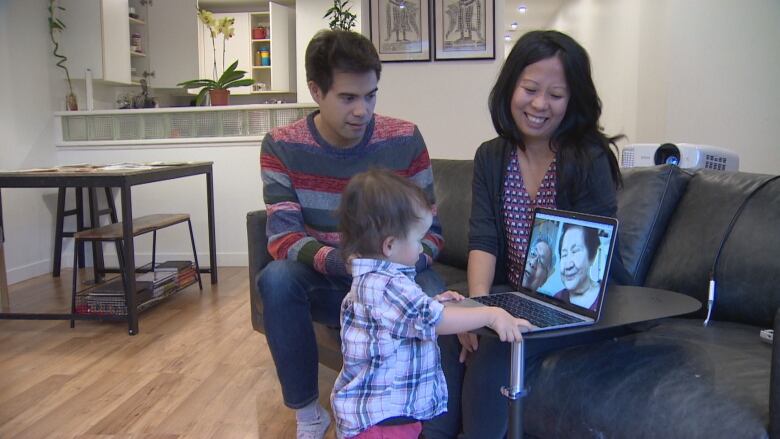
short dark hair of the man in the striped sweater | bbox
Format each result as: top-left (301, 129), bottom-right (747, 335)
top-left (306, 30), bottom-right (382, 95)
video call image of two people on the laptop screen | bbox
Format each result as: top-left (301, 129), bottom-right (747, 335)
top-left (523, 214), bottom-right (612, 311)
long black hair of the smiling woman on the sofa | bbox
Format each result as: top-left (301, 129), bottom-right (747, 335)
top-left (488, 30), bottom-right (624, 194)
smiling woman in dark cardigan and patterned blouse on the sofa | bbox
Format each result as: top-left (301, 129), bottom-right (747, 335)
top-left (424, 31), bottom-right (622, 439)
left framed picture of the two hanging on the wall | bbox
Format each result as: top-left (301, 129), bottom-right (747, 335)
top-left (369, 0), bottom-right (432, 62)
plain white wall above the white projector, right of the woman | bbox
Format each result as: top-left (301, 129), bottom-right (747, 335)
top-left (553, 0), bottom-right (780, 174)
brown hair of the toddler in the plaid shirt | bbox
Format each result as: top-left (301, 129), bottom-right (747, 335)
top-left (338, 169), bottom-right (431, 261)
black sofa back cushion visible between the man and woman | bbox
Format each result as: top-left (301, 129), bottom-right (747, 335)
top-left (431, 159), bottom-right (474, 270)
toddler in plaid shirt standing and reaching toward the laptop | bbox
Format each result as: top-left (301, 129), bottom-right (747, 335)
top-left (331, 169), bottom-right (531, 439)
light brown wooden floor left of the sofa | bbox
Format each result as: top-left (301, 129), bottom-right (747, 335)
top-left (0, 267), bottom-right (336, 439)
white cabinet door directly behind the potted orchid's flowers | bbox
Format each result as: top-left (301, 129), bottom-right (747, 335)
top-left (200, 12), bottom-right (252, 95)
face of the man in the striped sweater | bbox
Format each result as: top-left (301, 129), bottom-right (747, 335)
top-left (309, 70), bottom-right (378, 148)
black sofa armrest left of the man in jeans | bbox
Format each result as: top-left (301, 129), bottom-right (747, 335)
top-left (246, 210), bottom-right (272, 332)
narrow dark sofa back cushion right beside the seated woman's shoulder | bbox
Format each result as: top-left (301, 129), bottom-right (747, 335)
top-left (617, 165), bottom-right (691, 285)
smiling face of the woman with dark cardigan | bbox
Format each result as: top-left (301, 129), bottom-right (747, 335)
top-left (512, 56), bottom-right (569, 143)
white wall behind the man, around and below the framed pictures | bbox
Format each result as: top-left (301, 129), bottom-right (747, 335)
top-left (296, 0), bottom-right (504, 159)
